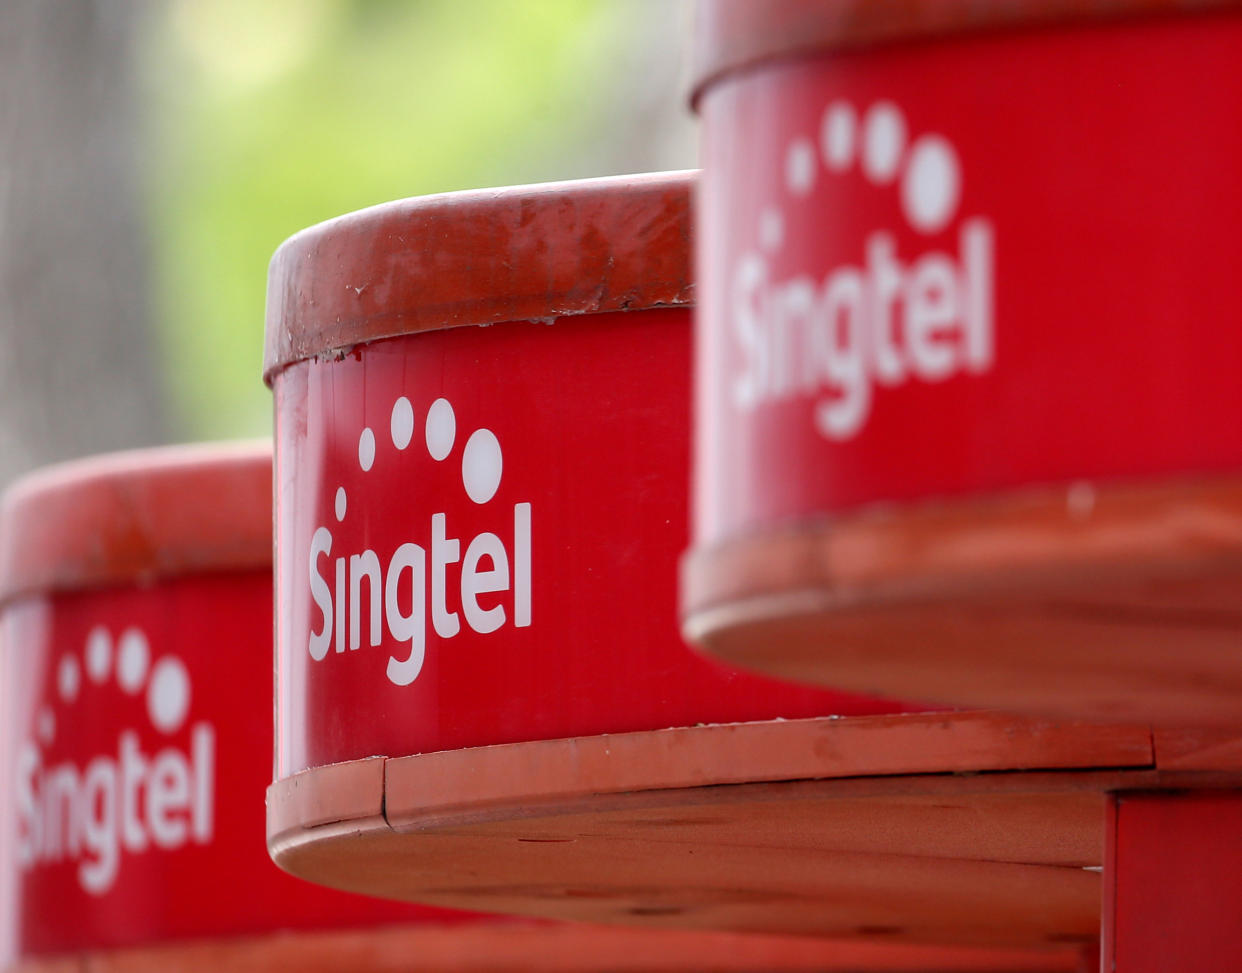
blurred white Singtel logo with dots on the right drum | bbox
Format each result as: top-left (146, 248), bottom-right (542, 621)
top-left (729, 101), bottom-right (995, 441)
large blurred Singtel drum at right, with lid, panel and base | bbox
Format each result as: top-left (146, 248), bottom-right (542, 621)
top-left (683, 0), bottom-right (1242, 724)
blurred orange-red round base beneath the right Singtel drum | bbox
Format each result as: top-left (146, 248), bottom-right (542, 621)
top-left (682, 477), bottom-right (1242, 727)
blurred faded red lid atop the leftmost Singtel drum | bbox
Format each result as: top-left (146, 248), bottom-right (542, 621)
top-left (0, 442), bottom-right (272, 601)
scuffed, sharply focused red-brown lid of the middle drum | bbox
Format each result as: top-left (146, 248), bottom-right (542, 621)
top-left (263, 171), bottom-right (694, 381)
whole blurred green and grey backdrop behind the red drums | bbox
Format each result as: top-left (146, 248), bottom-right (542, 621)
top-left (0, 0), bottom-right (696, 486)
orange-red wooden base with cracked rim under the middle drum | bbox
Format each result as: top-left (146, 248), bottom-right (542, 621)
top-left (268, 713), bottom-right (1240, 948)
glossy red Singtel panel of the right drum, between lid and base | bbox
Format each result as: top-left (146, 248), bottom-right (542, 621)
top-left (694, 15), bottom-right (1242, 546)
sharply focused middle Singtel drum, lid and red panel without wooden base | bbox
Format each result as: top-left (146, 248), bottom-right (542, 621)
top-left (267, 174), bottom-right (914, 777)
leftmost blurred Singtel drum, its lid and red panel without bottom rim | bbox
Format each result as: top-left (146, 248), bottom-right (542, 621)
top-left (0, 445), bottom-right (453, 962)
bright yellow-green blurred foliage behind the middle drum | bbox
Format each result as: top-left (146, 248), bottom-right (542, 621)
top-left (143, 0), bottom-right (693, 437)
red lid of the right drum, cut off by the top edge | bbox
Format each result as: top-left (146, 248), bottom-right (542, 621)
top-left (691, 0), bottom-right (1242, 103)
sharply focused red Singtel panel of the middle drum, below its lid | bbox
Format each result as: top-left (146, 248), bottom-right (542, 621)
top-left (274, 308), bottom-right (897, 777)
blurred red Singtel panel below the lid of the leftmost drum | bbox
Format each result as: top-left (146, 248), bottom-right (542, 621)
top-left (0, 570), bottom-right (465, 958)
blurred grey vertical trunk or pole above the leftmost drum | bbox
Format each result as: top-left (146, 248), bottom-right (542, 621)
top-left (0, 0), bottom-right (166, 485)
